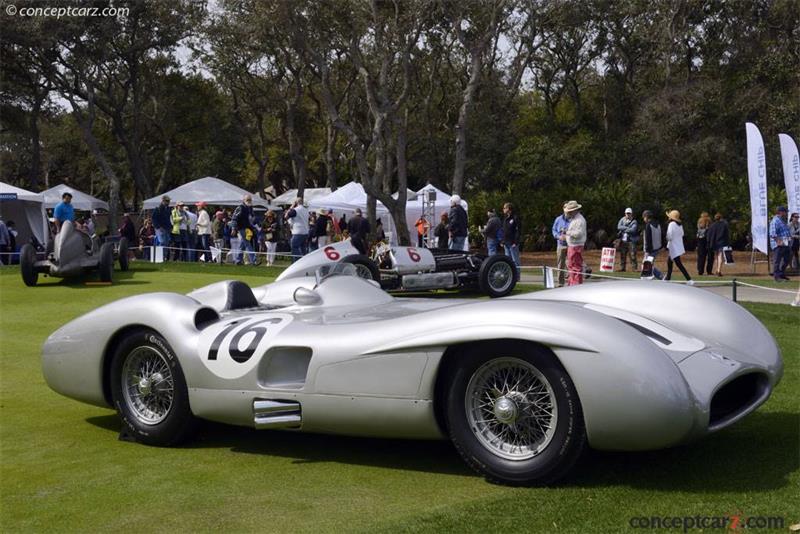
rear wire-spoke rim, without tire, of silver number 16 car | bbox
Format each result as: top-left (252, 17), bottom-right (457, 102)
top-left (121, 346), bottom-right (175, 425)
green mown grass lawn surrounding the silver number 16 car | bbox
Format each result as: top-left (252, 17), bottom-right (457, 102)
top-left (0, 264), bottom-right (800, 533)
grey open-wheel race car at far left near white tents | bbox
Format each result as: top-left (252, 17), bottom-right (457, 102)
top-left (19, 221), bottom-right (128, 286)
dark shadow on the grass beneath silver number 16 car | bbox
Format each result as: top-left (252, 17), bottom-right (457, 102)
top-left (87, 412), bottom-right (800, 493)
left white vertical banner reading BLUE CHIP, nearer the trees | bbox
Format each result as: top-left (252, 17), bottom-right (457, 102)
top-left (745, 122), bottom-right (769, 254)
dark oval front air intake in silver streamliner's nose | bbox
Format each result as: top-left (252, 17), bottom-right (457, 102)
top-left (708, 373), bottom-right (769, 430)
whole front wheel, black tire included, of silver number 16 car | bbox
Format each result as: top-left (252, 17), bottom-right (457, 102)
top-left (444, 342), bottom-right (586, 485)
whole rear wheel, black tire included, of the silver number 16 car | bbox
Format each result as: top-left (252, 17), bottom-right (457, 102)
top-left (109, 329), bottom-right (199, 447)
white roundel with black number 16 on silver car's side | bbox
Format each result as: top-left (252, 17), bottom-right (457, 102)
top-left (198, 314), bottom-right (292, 379)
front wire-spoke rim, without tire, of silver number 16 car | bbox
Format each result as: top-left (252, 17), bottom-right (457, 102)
top-left (464, 358), bottom-right (558, 460)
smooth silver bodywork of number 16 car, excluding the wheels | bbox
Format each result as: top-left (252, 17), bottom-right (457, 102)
top-left (43, 278), bottom-right (782, 450)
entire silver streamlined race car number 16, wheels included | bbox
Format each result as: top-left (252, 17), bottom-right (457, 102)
top-left (43, 264), bottom-right (783, 484)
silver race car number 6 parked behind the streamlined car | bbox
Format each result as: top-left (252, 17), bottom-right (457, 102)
top-left (278, 239), bottom-right (519, 297)
